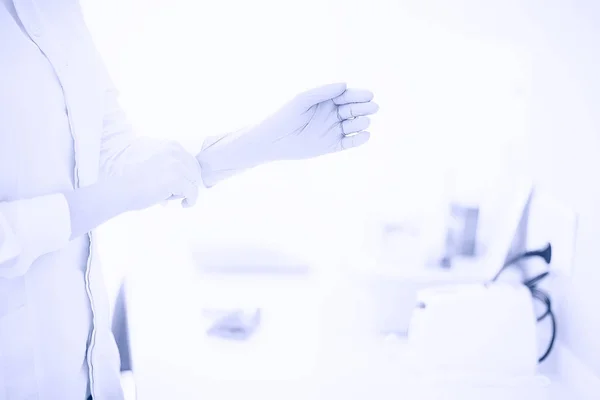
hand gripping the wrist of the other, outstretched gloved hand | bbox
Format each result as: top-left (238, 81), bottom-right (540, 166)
top-left (118, 142), bottom-right (202, 210)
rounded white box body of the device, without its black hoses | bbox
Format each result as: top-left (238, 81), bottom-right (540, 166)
top-left (408, 283), bottom-right (538, 377)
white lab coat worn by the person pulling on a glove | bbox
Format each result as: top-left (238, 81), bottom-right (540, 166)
top-left (0, 0), bottom-right (165, 400)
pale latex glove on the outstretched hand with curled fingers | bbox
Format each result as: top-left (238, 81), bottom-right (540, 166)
top-left (197, 83), bottom-right (379, 186)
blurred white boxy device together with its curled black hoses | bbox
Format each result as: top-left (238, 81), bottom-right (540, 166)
top-left (408, 205), bottom-right (556, 399)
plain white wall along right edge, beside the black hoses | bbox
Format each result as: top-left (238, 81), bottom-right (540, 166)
top-left (531, 1), bottom-right (600, 376)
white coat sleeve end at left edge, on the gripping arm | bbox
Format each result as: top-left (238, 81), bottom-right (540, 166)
top-left (0, 194), bottom-right (71, 278)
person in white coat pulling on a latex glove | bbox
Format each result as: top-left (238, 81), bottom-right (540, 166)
top-left (0, 0), bottom-right (378, 400)
